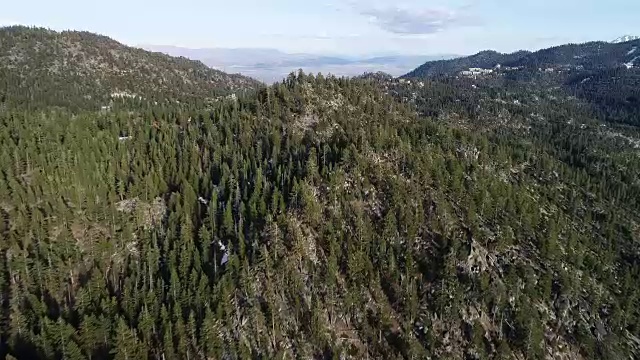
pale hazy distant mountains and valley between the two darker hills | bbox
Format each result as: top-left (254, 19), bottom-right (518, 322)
top-left (141, 45), bottom-right (457, 83)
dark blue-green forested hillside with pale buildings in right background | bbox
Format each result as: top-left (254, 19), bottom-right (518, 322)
top-left (404, 40), bottom-right (640, 125)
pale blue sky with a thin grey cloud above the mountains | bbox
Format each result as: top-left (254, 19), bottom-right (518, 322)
top-left (0, 0), bottom-right (640, 55)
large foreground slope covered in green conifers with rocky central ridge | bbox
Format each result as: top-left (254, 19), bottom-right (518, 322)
top-left (0, 74), bottom-right (640, 359)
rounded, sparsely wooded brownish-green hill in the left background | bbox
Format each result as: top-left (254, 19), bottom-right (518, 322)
top-left (0, 26), bottom-right (259, 108)
